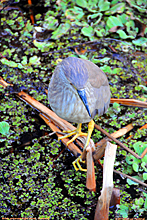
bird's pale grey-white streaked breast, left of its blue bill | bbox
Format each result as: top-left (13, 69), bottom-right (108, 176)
top-left (48, 84), bottom-right (91, 123)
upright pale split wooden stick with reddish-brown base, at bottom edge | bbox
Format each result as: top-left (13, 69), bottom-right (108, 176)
top-left (94, 142), bottom-right (117, 220)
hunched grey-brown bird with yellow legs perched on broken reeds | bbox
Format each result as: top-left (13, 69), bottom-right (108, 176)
top-left (48, 57), bottom-right (110, 170)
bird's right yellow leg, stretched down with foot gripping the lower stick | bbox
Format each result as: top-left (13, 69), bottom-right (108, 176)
top-left (73, 120), bottom-right (94, 171)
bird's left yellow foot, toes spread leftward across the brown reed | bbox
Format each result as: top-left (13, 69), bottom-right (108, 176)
top-left (58, 123), bottom-right (87, 146)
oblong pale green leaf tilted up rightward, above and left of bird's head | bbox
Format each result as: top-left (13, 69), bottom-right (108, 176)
top-left (51, 23), bottom-right (70, 40)
